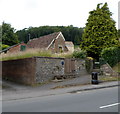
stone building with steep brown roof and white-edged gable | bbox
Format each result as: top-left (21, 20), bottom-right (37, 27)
top-left (27, 32), bottom-right (72, 53)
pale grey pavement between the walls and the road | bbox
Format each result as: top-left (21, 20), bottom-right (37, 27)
top-left (0, 75), bottom-right (120, 101)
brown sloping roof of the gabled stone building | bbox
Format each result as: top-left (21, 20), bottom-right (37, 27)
top-left (27, 32), bottom-right (61, 48)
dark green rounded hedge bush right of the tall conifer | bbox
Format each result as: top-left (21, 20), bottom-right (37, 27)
top-left (101, 46), bottom-right (120, 67)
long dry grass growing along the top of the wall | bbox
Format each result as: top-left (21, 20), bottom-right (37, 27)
top-left (0, 49), bottom-right (73, 61)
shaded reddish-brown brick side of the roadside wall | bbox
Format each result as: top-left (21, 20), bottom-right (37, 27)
top-left (2, 58), bottom-right (36, 85)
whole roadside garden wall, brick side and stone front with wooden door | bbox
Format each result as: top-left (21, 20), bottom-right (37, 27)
top-left (2, 57), bottom-right (87, 85)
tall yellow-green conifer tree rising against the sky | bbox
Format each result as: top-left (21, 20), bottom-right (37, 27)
top-left (80, 3), bottom-right (118, 59)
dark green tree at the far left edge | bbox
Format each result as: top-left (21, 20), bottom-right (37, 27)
top-left (2, 22), bottom-right (19, 46)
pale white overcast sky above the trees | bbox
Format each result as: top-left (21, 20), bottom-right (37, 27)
top-left (0, 0), bottom-right (119, 30)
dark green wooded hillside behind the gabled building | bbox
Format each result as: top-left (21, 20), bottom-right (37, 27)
top-left (17, 25), bottom-right (83, 45)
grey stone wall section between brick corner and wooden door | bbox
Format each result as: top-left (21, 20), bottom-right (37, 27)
top-left (36, 57), bottom-right (64, 83)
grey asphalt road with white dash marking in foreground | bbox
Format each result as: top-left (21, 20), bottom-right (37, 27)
top-left (2, 87), bottom-right (119, 112)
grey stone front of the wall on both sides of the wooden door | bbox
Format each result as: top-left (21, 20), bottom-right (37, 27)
top-left (36, 57), bottom-right (87, 83)
